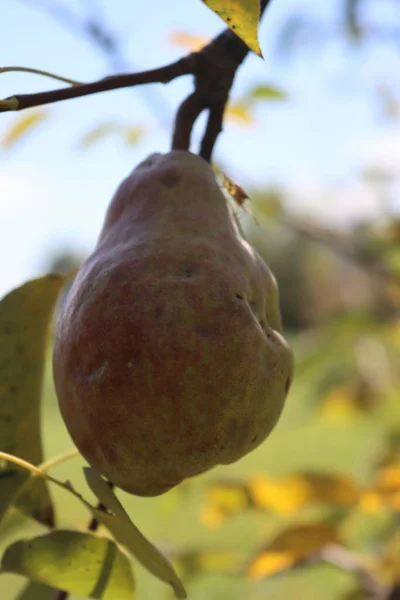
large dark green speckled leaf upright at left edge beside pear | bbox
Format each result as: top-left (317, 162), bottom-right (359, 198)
top-left (0, 275), bottom-right (64, 526)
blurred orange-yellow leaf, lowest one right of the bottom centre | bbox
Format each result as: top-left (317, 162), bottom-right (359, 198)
top-left (247, 522), bottom-right (339, 579)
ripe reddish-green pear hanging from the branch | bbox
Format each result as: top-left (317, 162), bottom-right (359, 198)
top-left (54, 151), bottom-right (293, 496)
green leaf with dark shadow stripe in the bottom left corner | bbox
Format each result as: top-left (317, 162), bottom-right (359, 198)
top-left (1, 530), bottom-right (135, 600)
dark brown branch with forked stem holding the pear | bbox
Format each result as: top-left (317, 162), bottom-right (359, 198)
top-left (0, 0), bottom-right (270, 161)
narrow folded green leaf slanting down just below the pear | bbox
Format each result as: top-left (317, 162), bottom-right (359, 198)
top-left (84, 468), bottom-right (186, 598)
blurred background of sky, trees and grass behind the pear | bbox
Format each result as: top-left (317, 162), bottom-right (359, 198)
top-left (0, 0), bottom-right (400, 600)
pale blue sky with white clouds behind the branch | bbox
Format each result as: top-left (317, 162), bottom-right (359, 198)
top-left (0, 0), bottom-right (400, 295)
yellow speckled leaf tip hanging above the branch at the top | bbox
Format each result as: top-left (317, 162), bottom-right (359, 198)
top-left (203, 0), bottom-right (262, 56)
